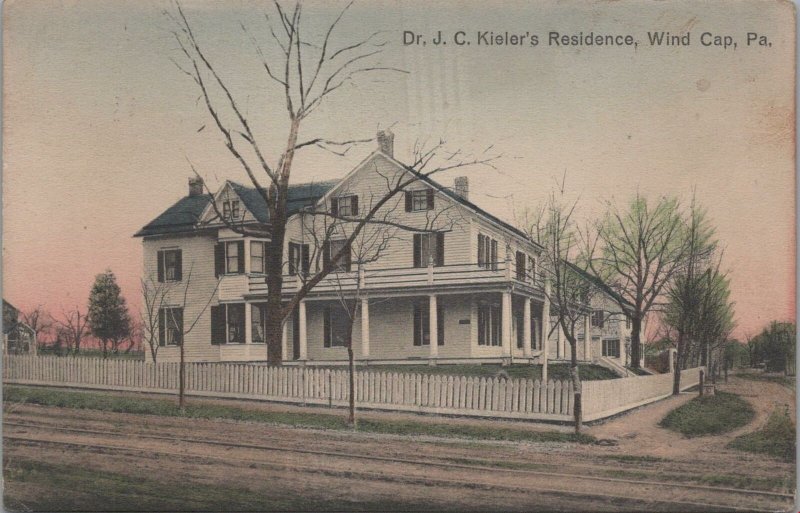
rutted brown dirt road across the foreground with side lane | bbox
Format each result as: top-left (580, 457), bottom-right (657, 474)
top-left (3, 374), bottom-right (792, 511)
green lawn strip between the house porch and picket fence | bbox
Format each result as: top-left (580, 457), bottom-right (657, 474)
top-left (352, 363), bottom-right (619, 381)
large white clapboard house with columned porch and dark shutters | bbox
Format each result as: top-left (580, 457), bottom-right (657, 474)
top-left (136, 131), bottom-right (629, 365)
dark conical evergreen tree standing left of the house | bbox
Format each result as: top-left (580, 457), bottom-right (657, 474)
top-left (89, 269), bottom-right (131, 358)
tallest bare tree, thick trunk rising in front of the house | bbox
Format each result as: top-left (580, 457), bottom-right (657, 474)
top-left (165, 1), bottom-right (496, 365)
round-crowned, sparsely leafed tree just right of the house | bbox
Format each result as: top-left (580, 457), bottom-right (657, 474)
top-left (589, 193), bottom-right (686, 369)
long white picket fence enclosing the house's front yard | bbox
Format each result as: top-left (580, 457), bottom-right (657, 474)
top-left (3, 355), bottom-right (696, 421)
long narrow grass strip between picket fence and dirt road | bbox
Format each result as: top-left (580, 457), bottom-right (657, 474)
top-left (3, 386), bottom-right (595, 443)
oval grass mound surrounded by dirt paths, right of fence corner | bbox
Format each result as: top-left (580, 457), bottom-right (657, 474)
top-left (658, 392), bottom-right (755, 438)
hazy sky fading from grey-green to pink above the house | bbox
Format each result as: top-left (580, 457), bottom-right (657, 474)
top-left (2, 0), bottom-right (796, 336)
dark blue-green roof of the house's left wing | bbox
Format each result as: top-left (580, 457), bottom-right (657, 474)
top-left (134, 181), bottom-right (336, 237)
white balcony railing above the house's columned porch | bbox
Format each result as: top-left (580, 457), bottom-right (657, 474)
top-left (242, 262), bottom-right (536, 299)
